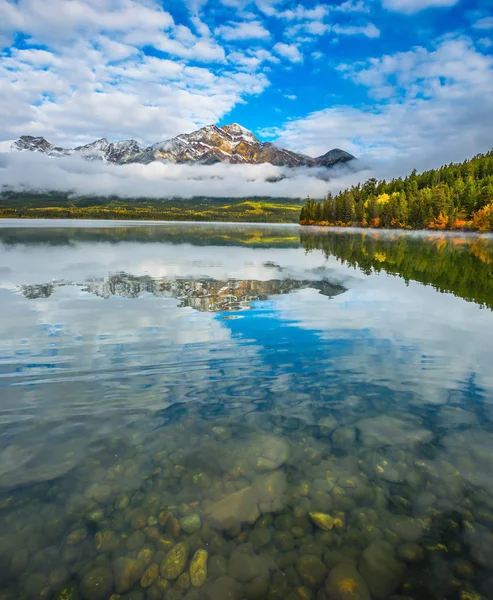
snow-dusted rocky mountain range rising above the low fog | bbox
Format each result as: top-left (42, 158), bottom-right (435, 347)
top-left (4, 123), bottom-right (354, 167)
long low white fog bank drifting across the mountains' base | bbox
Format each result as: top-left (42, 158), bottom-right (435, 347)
top-left (0, 152), bottom-right (371, 198)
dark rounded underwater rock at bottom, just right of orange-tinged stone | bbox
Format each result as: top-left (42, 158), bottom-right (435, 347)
top-left (358, 540), bottom-right (406, 600)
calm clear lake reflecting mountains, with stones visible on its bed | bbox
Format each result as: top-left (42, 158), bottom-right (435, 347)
top-left (0, 221), bottom-right (493, 600)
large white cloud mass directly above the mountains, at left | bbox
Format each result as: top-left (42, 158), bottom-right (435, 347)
top-left (0, 36), bottom-right (269, 145)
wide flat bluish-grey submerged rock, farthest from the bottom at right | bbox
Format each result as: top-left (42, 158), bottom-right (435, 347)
top-left (356, 415), bottom-right (433, 448)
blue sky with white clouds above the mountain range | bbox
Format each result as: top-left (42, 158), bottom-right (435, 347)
top-left (0, 0), bottom-right (493, 195)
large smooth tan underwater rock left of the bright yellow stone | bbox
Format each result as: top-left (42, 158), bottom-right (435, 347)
top-left (204, 487), bottom-right (260, 533)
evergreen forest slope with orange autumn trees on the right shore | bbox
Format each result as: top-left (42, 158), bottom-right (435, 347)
top-left (300, 150), bottom-right (493, 232)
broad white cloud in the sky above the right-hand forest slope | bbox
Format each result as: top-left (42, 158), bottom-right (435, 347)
top-left (270, 38), bottom-right (493, 176)
